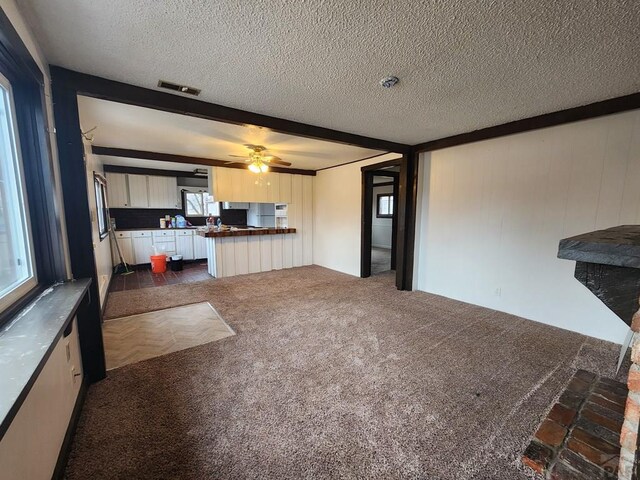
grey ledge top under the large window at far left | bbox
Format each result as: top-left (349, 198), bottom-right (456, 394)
top-left (0, 279), bottom-right (91, 438)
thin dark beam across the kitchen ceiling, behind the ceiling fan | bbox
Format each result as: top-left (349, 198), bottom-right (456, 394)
top-left (91, 145), bottom-right (316, 176)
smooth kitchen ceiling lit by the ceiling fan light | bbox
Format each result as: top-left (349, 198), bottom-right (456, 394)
top-left (78, 96), bottom-right (384, 170)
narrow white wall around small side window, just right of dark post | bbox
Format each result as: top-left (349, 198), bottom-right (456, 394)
top-left (82, 141), bottom-right (113, 307)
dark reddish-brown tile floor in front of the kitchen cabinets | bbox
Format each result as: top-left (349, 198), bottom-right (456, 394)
top-left (109, 262), bottom-right (212, 292)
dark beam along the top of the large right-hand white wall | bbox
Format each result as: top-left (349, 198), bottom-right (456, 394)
top-left (413, 93), bottom-right (640, 153)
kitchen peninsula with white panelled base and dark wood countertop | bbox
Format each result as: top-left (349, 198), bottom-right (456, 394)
top-left (197, 227), bottom-right (296, 278)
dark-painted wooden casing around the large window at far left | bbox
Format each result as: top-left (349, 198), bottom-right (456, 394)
top-left (0, 8), bottom-right (69, 328)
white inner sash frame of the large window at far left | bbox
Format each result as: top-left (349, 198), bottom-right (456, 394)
top-left (0, 72), bottom-right (38, 312)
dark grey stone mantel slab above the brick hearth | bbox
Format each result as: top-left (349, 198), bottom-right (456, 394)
top-left (558, 225), bottom-right (640, 268)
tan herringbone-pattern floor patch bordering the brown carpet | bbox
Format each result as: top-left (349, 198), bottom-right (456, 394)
top-left (102, 302), bottom-right (235, 370)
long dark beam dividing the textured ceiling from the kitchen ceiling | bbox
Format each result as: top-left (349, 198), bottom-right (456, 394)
top-left (50, 65), bottom-right (411, 153)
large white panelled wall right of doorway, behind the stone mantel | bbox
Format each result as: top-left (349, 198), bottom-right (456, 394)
top-left (414, 111), bottom-right (640, 343)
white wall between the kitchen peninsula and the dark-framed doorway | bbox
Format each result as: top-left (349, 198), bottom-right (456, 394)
top-left (313, 153), bottom-right (398, 276)
